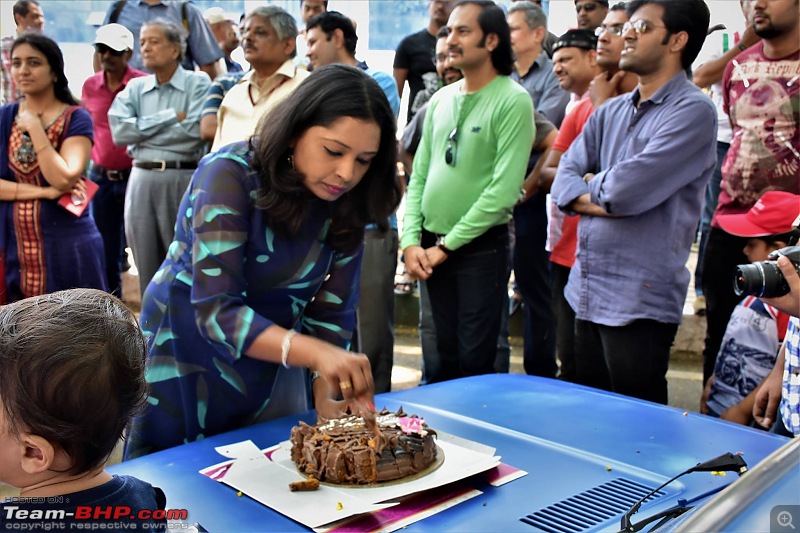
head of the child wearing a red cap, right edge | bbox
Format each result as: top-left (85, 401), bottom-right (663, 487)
top-left (717, 191), bottom-right (800, 263)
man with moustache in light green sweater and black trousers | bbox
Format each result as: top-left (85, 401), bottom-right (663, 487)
top-left (400, 0), bottom-right (534, 383)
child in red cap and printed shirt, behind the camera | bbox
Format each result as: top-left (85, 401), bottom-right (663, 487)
top-left (701, 191), bottom-right (800, 429)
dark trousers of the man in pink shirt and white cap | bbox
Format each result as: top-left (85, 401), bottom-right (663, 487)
top-left (88, 167), bottom-right (128, 297)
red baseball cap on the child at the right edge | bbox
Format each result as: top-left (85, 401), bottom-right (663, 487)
top-left (717, 191), bottom-right (800, 237)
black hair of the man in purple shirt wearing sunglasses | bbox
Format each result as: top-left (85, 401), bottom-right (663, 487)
top-left (625, 0), bottom-right (711, 72)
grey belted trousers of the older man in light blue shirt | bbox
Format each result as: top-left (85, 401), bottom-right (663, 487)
top-left (125, 167), bottom-right (194, 293)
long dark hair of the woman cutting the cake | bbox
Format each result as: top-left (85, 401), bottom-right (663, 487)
top-left (251, 64), bottom-right (401, 250)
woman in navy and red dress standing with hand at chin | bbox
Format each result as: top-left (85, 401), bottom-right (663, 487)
top-left (0, 33), bottom-right (107, 303)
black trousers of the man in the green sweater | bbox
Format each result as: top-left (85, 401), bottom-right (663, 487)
top-left (422, 225), bottom-right (508, 383)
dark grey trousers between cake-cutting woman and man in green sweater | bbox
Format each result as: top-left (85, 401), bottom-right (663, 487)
top-left (356, 229), bottom-right (397, 393)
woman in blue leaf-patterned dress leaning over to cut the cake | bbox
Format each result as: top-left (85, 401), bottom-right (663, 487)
top-left (125, 65), bottom-right (401, 458)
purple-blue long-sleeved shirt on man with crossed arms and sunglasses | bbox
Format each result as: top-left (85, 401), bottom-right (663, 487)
top-left (552, 72), bottom-right (717, 326)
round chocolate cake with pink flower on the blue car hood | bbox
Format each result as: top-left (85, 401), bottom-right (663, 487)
top-left (291, 408), bottom-right (437, 485)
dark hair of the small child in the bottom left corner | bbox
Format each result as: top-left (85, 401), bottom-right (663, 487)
top-left (0, 289), bottom-right (147, 475)
